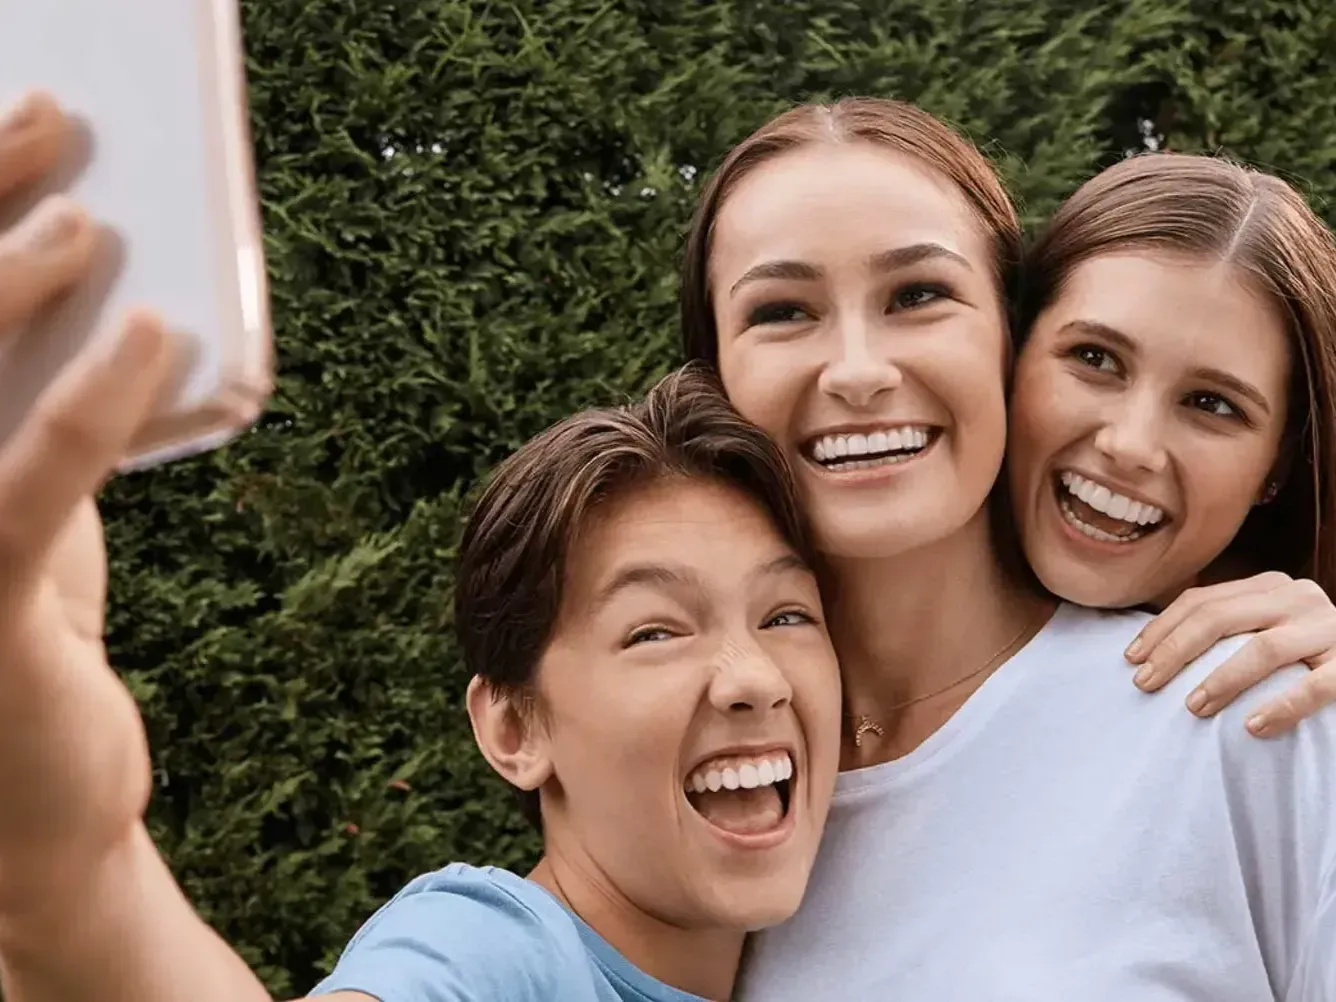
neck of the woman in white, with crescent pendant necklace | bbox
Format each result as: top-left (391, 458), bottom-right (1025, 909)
top-left (823, 508), bottom-right (1057, 768)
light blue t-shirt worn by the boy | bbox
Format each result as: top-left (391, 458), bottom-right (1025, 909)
top-left (311, 863), bottom-right (703, 1002)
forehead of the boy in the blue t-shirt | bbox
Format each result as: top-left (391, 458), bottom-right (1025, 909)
top-left (564, 477), bottom-right (791, 611)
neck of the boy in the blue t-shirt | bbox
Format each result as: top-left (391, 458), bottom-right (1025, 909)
top-left (529, 839), bottom-right (744, 1002)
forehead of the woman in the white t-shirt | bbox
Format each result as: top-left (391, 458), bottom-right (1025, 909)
top-left (711, 142), bottom-right (989, 282)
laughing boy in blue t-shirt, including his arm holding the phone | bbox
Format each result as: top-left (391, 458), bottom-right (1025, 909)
top-left (0, 92), bottom-right (840, 1002)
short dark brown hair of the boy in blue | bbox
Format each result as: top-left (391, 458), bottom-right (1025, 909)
top-left (454, 365), bottom-right (814, 828)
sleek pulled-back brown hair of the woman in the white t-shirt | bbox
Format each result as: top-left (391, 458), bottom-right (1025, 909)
top-left (680, 98), bottom-right (1021, 365)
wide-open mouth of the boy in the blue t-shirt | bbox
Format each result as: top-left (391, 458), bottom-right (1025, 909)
top-left (685, 751), bottom-right (795, 838)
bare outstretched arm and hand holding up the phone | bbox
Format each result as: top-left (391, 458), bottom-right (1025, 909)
top-left (0, 98), bottom-right (344, 1002)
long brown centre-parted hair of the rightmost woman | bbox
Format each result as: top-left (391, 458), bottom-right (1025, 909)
top-left (1018, 154), bottom-right (1336, 595)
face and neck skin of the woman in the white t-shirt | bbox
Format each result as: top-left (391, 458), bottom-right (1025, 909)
top-left (709, 143), bottom-right (1053, 767)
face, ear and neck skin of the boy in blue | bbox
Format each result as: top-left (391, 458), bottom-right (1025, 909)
top-left (469, 480), bottom-right (840, 998)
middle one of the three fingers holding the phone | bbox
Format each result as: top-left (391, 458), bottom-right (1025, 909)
top-left (0, 195), bottom-right (98, 330)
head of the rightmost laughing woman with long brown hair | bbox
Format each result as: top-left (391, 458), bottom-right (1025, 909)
top-left (1007, 154), bottom-right (1336, 733)
